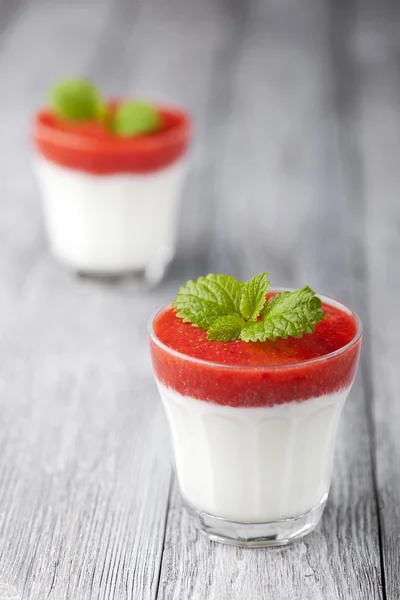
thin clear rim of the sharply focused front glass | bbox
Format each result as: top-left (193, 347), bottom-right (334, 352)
top-left (147, 287), bottom-right (364, 371)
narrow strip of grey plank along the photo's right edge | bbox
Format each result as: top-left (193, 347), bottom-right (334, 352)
top-left (351, 2), bottom-right (400, 600)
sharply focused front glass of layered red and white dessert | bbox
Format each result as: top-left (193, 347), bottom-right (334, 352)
top-left (149, 276), bottom-right (362, 547)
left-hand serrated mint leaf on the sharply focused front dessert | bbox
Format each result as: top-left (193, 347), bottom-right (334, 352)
top-left (172, 274), bottom-right (243, 330)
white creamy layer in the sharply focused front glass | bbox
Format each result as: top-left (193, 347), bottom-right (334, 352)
top-left (158, 382), bottom-right (350, 523)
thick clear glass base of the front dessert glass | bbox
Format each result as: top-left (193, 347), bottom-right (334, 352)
top-left (184, 497), bottom-right (326, 548)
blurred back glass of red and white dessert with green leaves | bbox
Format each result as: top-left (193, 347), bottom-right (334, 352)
top-left (33, 80), bottom-right (191, 283)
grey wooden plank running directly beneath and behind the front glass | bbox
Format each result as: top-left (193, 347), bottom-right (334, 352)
top-left (159, 1), bottom-right (382, 600)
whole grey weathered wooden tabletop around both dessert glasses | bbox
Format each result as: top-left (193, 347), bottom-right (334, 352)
top-left (0, 0), bottom-right (400, 600)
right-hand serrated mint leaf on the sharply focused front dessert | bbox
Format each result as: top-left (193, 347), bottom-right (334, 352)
top-left (240, 286), bottom-right (324, 342)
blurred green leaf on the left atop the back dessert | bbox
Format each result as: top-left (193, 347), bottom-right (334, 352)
top-left (50, 79), bottom-right (106, 121)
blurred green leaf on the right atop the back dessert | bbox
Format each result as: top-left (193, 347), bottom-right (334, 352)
top-left (112, 101), bottom-right (162, 137)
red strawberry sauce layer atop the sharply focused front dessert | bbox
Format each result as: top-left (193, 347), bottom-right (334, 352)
top-left (150, 299), bottom-right (361, 407)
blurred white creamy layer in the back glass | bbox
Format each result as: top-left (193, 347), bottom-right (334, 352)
top-left (36, 157), bottom-right (185, 278)
